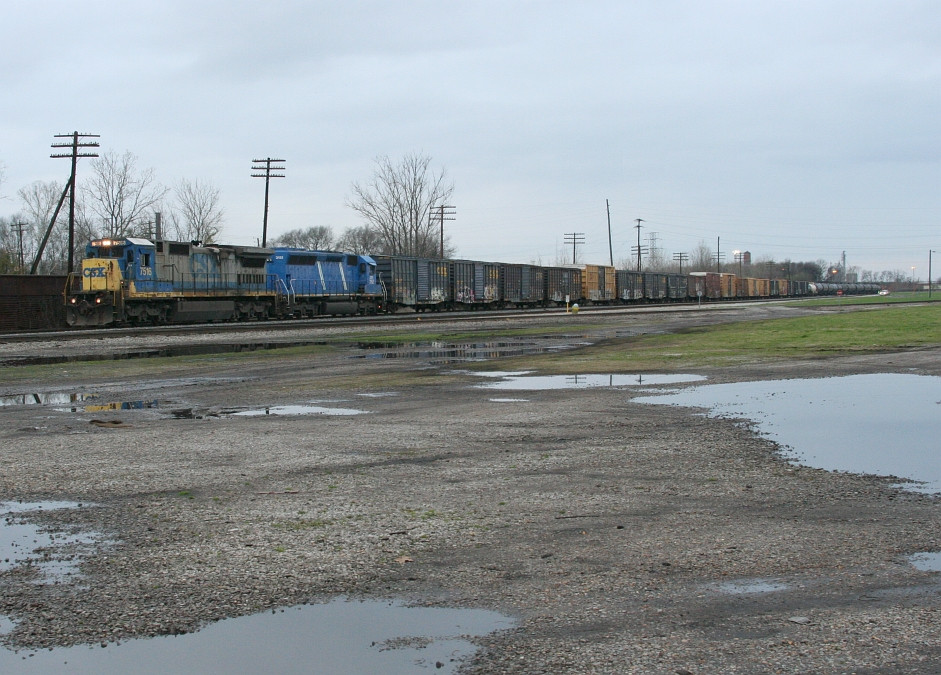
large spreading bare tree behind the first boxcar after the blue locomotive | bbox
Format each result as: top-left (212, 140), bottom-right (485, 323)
top-left (347, 155), bottom-right (454, 256)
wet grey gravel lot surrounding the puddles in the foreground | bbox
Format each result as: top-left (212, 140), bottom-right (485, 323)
top-left (0, 310), bottom-right (941, 673)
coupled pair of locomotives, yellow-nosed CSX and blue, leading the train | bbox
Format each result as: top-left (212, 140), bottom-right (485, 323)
top-left (66, 237), bottom-right (383, 326)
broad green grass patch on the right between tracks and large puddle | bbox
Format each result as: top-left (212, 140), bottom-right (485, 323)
top-left (500, 304), bottom-right (941, 373)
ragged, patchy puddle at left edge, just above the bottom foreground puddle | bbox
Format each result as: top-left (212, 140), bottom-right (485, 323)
top-left (0, 502), bottom-right (103, 584)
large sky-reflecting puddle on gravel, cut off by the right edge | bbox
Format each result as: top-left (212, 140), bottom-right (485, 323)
top-left (633, 374), bottom-right (941, 492)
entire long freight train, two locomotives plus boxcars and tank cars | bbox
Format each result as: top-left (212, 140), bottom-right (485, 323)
top-left (66, 237), bottom-right (879, 326)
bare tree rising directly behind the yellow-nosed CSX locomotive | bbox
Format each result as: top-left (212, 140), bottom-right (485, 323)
top-left (83, 151), bottom-right (167, 237)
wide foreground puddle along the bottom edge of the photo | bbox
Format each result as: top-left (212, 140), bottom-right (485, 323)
top-left (0, 599), bottom-right (514, 675)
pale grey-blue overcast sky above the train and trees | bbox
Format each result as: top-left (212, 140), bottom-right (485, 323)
top-left (0, 0), bottom-right (941, 278)
